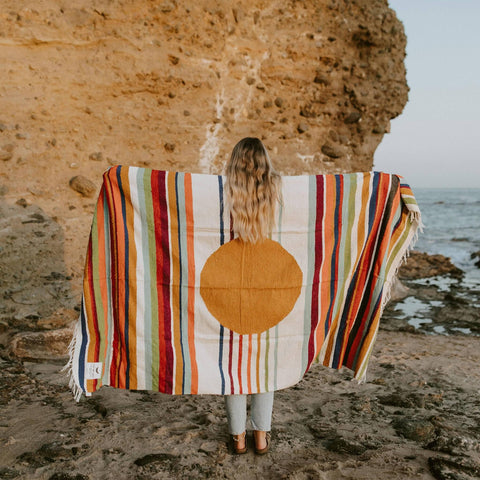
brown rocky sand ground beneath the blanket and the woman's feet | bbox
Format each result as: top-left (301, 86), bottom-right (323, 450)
top-left (0, 331), bottom-right (480, 480)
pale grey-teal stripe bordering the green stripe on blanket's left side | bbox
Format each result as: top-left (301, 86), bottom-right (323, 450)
top-left (136, 169), bottom-right (152, 390)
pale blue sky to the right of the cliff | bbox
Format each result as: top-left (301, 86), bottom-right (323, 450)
top-left (374, 0), bottom-right (480, 189)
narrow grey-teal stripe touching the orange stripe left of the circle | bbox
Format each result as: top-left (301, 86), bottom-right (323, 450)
top-left (175, 173), bottom-right (192, 392)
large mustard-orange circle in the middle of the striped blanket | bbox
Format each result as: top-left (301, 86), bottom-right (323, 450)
top-left (200, 239), bottom-right (302, 335)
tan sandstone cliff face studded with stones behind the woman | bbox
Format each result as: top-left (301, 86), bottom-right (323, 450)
top-left (0, 0), bottom-right (408, 358)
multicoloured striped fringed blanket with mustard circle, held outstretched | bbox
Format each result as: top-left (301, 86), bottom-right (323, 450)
top-left (67, 166), bottom-right (420, 399)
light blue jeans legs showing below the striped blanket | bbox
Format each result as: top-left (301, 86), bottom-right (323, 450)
top-left (225, 392), bottom-right (273, 435)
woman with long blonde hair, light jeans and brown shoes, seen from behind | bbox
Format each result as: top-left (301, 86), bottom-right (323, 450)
top-left (225, 137), bottom-right (281, 455)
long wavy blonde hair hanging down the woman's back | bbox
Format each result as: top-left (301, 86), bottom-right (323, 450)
top-left (225, 137), bottom-right (282, 243)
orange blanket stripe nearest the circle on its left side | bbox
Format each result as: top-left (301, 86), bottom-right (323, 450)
top-left (185, 173), bottom-right (198, 394)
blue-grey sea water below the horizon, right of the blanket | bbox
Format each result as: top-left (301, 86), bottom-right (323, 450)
top-left (414, 188), bottom-right (480, 285)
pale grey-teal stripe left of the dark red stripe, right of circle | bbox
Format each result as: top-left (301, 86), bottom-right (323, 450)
top-left (301, 175), bottom-right (317, 375)
